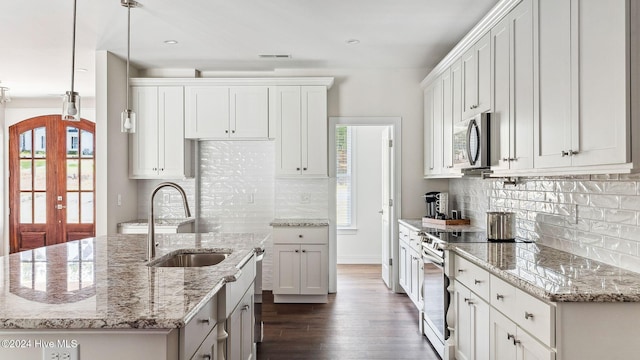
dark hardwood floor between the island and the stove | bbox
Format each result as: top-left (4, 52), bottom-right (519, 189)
top-left (258, 265), bottom-right (439, 360)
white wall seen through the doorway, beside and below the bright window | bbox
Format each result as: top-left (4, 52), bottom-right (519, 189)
top-left (337, 126), bottom-right (386, 264)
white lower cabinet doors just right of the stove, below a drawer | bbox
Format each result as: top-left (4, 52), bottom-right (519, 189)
top-left (453, 281), bottom-right (490, 360)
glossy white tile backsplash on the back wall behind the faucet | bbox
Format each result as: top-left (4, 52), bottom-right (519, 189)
top-left (138, 141), bottom-right (329, 289)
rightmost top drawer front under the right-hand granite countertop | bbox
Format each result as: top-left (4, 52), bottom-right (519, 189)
top-left (512, 289), bottom-right (556, 347)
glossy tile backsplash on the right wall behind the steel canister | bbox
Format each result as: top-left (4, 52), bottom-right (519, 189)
top-left (449, 174), bottom-right (640, 272)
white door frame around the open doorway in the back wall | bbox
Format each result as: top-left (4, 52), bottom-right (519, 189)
top-left (329, 116), bottom-right (403, 293)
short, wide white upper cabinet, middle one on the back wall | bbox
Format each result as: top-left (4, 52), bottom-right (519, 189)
top-left (185, 86), bottom-right (269, 140)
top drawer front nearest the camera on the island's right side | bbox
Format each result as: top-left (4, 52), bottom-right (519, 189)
top-left (180, 296), bottom-right (218, 359)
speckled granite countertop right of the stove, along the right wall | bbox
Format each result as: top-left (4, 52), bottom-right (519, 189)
top-left (447, 243), bottom-right (640, 302)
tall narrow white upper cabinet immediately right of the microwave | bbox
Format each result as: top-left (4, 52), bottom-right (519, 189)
top-left (490, 0), bottom-right (534, 171)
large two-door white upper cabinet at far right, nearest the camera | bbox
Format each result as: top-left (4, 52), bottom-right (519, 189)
top-left (535, 0), bottom-right (637, 169)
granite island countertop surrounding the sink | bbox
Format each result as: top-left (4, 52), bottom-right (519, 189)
top-left (0, 233), bottom-right (270, 329)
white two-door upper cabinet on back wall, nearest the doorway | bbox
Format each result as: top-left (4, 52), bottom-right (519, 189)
top-left (275, 86), bottom-right (328, 177)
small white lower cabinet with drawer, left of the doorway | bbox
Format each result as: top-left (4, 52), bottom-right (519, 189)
top-left (273, 226), bottom-right (329, 303)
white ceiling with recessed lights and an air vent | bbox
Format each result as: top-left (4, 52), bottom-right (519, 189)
top-left (0, 0), bottom-right (498, 98)
